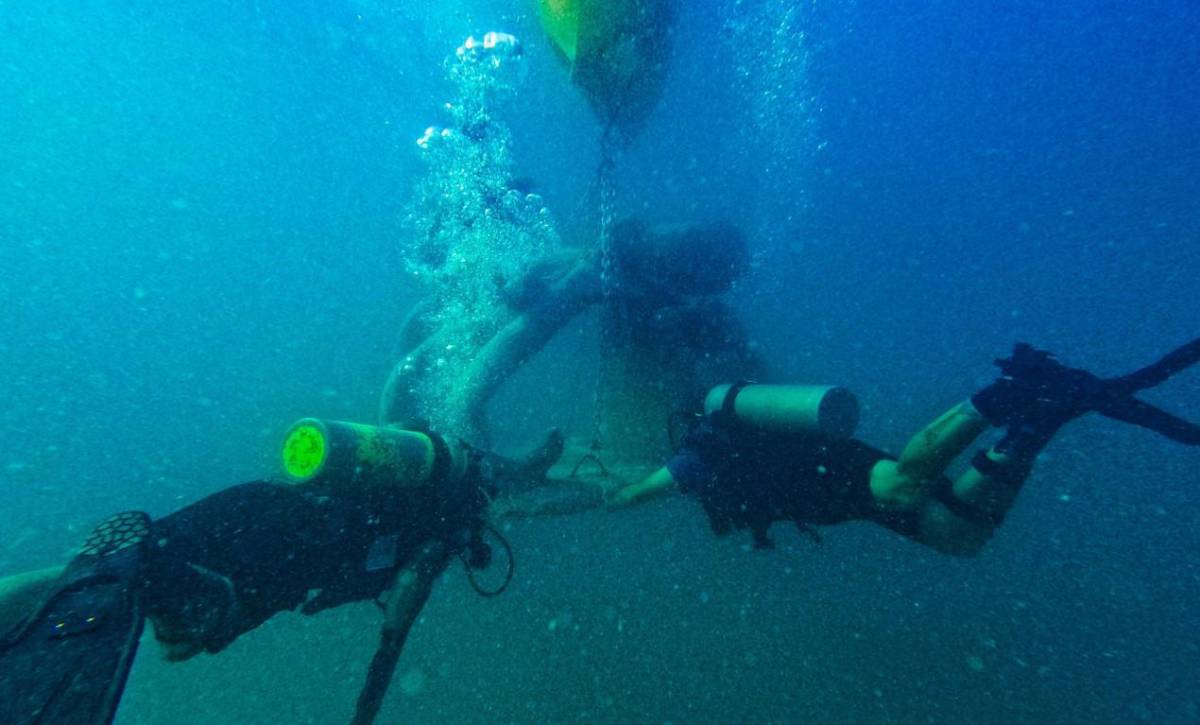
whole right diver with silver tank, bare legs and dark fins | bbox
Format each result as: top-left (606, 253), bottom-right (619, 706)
top-left (610, 340), bottom-right (1200, 556)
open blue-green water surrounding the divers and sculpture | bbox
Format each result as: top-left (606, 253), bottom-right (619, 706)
top-left (0, 0), bottom-right (1200, 723)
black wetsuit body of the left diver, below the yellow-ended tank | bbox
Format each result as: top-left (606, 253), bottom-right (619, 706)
top-left (143, 481), bottom-right (486, 652)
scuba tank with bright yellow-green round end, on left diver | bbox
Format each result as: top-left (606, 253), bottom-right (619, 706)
top-left (281, 418), bottom-right (468, 493)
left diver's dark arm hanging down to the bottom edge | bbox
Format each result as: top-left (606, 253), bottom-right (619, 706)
top-left (353, 541), bottom-right (450, 725)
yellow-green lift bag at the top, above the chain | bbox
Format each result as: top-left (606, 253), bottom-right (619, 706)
top-left (538, 0), bottom-right (676, 133)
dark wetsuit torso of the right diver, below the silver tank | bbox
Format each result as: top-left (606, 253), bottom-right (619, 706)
top-left (667, 417), bottom-right (914, 546)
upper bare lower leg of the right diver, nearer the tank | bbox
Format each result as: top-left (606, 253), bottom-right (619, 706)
top-left (871, 401), bottom-right (991, 509)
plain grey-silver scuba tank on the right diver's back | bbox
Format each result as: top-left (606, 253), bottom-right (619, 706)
top-left (704, 383), bottom-right (858, 438)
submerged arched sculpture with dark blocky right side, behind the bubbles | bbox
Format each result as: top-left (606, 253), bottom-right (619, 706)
top-left (379, 221), bottom-right (762, 458)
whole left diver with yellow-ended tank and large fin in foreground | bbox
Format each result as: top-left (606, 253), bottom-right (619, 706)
top-left (0, 419), bottom-right (563, 724)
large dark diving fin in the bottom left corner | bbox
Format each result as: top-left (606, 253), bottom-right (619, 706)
top-left (0, 511), bottom-right (150, 725)
